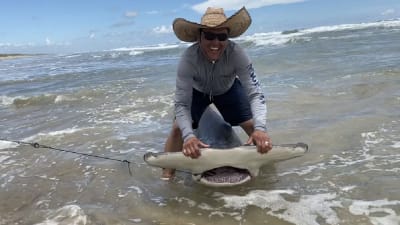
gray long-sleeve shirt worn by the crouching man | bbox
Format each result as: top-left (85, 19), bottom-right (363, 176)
top-left (175, 41), bottom-right (267, 141)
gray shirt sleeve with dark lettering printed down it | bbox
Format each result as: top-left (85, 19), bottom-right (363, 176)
top-left (233, 45), bottom-right (267, 131)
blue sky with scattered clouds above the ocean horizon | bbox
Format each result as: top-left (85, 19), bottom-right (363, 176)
top-left (0, 0), bottom-right (400, 54)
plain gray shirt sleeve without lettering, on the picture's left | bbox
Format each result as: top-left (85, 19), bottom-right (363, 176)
top-left (175, 53), bottom-right (195, 141)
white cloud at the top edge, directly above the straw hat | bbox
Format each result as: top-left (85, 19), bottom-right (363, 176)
top-left (192, 0), bottom-right (307, 14)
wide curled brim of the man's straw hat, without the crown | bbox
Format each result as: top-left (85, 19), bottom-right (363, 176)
top-left (172, 7), bottom-right (251, 42)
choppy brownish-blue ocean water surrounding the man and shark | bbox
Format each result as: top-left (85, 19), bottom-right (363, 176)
top-left (0, 20), bottom-right (400, 225)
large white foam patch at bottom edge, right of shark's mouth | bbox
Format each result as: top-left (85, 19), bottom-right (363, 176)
top-left (220, 190), bottom-right (342, 225)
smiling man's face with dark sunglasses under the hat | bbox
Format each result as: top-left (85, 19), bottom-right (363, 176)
top-left (200, 28), bottom-right (228, 61)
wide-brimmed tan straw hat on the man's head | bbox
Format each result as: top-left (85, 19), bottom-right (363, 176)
top-left (172, 7), bottom-right (251, 42)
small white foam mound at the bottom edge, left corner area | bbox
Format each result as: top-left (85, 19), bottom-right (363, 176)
top-left (36, 205), bottom-right (87, 225)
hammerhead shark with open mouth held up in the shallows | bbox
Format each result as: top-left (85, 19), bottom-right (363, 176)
top-left (144, 105), bottom-right (308, 187)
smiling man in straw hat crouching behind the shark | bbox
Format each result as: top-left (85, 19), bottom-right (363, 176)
top-left (162, 7), bottom-right (272, 179)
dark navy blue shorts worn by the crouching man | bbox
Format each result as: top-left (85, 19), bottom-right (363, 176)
top-left (191, 79), bottom-right (253, 129)
